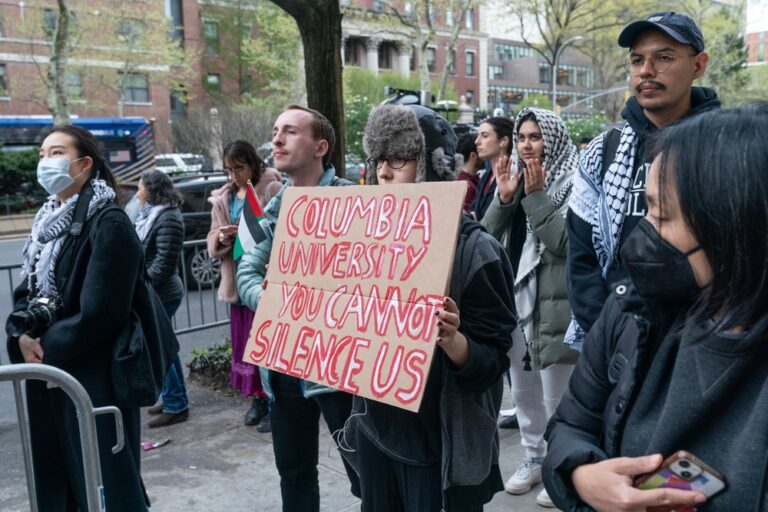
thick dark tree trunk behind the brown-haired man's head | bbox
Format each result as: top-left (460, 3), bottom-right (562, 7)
top-left (272, 0), bottom-right (344, 176)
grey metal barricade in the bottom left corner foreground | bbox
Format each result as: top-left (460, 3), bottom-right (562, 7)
top-left (0, 364), bottom-right (125, 512)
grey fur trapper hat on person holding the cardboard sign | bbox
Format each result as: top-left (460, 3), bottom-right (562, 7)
top-left (363, 105), bottom-right (457, 184)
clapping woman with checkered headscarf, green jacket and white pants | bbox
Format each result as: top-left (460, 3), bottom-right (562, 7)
top-left (482, 108), bottom-right (578, 507)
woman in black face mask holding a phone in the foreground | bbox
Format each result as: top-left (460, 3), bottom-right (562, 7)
top-left (543, 104), bottom-right (768, 511)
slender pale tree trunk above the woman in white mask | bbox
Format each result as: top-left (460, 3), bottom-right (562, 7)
top-left (46, 0), bottom-right (72, 125)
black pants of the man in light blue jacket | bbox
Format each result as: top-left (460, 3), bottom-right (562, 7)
top-left (270, 373), bottom-right (360, 512)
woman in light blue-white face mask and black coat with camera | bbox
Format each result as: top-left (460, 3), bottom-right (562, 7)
top-left (6, 126), bottom-right (148, 512)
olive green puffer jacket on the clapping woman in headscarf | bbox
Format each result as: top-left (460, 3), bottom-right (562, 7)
top-left (482, 187), bottom-right (579, 369)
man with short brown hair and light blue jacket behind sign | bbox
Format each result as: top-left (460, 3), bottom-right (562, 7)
top-left (237, 105), bottom-right (360, 512)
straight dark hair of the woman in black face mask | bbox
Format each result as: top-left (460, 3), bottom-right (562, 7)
top-left (652, 103), bottom-right (768, 339)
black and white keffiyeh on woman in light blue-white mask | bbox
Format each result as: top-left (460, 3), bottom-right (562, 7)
top-left (21, 179), bottom-right (115, 299)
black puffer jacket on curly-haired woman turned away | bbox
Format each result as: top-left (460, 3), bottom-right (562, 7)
top-left (144, 208), bottom-right (184, 302)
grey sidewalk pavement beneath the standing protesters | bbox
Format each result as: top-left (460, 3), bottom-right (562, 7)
top-left (0, 328), bottom-right (545, 512)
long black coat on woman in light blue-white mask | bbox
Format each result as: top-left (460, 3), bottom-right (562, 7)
top-left (6, 202), bottom-right (146, 512)
